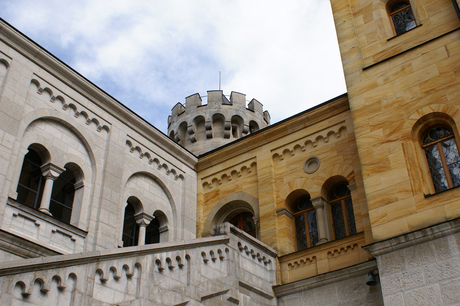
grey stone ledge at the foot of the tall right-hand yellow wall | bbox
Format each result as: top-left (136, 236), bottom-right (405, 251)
top-left (363, 218), bottom-right (460, 257)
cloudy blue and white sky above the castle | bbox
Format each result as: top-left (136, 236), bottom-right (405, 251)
top-left (0, 0), bottom-right (346, 133)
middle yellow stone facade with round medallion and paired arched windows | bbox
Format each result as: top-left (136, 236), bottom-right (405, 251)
top-left (196, 95), bottom-right (373, 283)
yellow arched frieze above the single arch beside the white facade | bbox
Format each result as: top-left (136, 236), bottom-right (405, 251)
top-left (201, 159), bottom-right (257, 192)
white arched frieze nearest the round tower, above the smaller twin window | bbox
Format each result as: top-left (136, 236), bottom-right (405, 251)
top-left (126, 135), bottom-right (185, 180)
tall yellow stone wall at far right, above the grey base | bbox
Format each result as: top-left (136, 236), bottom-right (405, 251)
top-left (331, 0), bottom-right (460, 241)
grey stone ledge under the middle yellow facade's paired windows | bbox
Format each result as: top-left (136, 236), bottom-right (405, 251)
top-left (273, 260), bottom-right (377, 298)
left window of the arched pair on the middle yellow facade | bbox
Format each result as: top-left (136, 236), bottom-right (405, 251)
top-left (294, 195), bottom-right (318, 251)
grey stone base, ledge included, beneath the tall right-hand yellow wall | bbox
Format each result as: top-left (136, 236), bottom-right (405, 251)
top-left (366, 219), bottom-right (460, 306)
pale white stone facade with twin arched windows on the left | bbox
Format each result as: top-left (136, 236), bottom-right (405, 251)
top-left (0, 24), bottom-right (196, 260)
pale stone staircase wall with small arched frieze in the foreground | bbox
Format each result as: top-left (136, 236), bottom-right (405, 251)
top-left (0, 223), bottom-right (276, 306)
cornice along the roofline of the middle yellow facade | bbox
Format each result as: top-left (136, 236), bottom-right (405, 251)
top-left (195, 94), bottom-right (350, 171)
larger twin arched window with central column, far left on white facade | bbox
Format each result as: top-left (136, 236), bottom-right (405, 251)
top-left (16, 147), bottom-right (83, 223)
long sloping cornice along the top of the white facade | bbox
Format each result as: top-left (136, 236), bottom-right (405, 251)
top-left (0, 19), bottom-right (197, 169)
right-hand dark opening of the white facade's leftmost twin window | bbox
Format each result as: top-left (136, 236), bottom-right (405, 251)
top-left (49, 169), bottom-right (75, 223)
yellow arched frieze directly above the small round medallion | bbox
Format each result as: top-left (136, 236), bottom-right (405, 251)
top-left (272, 121), bottom-right (347, 162)
